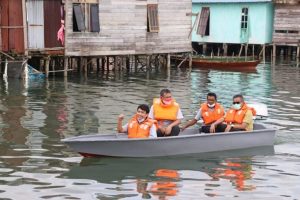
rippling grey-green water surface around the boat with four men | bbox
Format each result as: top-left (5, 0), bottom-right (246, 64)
top-left (0, 64), bottom-right (300, 200)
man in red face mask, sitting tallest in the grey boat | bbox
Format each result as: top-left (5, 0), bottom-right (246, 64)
top-left (149, 89), bottom-right (183, 137)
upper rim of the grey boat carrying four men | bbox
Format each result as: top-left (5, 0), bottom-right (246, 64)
top-left (61, 128), bottom-right (277, 143)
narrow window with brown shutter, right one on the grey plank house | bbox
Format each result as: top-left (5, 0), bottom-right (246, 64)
top-left (147, 4), bottom-right (159, 33)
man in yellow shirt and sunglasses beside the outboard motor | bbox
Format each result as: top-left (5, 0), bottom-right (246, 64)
top-left (212, 94), bottom-right (256, 132)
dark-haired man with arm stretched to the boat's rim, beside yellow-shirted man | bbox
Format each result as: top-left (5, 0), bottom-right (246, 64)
top-left (182, 92), bottom-right (224, 133)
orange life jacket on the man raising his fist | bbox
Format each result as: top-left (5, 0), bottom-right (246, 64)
top-left (128, 115), bottom-right (156, 138)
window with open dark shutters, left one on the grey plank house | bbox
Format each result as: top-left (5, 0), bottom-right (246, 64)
top-left (73, 3), bottom-right (100, 32)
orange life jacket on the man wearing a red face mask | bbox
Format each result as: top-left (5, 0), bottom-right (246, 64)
top-left (153, 99), bottom-right (179, 121)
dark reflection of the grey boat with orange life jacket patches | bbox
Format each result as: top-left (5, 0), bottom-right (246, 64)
top-left (62, 146), bottom-right (274, 193)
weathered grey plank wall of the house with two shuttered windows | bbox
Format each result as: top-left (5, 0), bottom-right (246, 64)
top-left (65, 0), bottom-right (192, 56)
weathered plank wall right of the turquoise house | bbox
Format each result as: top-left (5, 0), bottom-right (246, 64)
top-left (273, 4), bottom-right (300, 46)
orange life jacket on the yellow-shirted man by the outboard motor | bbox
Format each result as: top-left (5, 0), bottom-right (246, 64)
top-left (225, 103), bottom-right (256, 124)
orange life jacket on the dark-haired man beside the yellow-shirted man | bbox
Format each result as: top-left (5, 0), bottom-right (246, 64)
top-left (200, 103), bottom-right (224, 125)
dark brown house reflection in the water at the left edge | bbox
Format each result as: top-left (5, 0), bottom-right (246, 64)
top-left (0, 79), bottom-right (29, 166)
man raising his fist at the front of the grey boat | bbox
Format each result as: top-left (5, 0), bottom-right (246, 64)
top-left (118, 104), bottom-right (157, 138)
